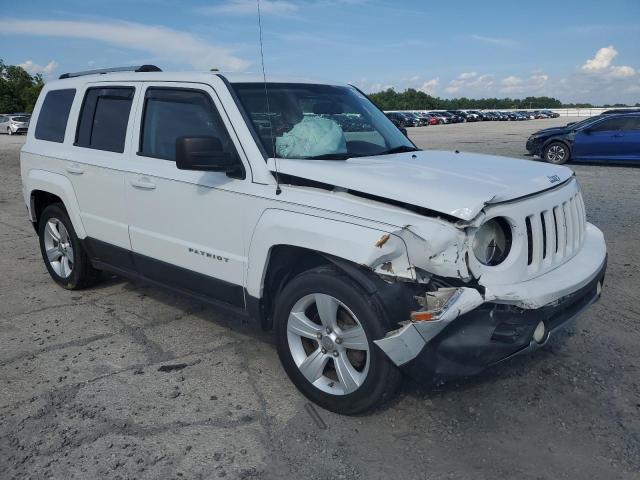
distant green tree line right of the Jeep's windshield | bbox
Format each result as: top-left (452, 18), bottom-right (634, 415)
top-left (369, 88), bottom-right (637, 110)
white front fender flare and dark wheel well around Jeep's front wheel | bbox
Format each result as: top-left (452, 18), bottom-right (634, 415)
top-left (246, 210), bottom-right (424, 330)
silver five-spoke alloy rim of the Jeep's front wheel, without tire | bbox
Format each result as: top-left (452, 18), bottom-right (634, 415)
top-left (287, 293), bottom-right (370, 395)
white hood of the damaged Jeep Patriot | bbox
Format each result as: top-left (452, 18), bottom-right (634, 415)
top-left (268, 150), bottom-right (573, 220)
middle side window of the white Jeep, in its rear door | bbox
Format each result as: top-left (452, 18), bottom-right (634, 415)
top-left (75, 87), bottom-right (135, 153)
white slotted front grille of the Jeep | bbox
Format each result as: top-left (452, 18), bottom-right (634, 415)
top-left (525, 191), bottom-right (586, 274)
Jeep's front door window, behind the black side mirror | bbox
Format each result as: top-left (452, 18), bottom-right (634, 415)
top-left (139, 87), bottom-right (235, 161)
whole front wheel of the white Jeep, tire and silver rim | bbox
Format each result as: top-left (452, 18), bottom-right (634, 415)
top-left (274, 267), bottom-right (401, 415)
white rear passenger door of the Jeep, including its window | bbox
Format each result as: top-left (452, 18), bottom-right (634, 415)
top-left (64, 82), bottom-right (139, 251)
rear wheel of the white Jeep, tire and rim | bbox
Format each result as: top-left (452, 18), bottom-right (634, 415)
top-left (38, 203), bottom-right (101, 290)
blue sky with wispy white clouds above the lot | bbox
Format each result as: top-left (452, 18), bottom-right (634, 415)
top-left (0, 0), bottom-right (640, 105)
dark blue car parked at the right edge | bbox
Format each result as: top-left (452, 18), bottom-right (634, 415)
top-left (526, 113), bottom-right (640, 165)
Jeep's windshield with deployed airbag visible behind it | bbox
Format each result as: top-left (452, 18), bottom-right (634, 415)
top-left (233, 83), bottom-right (416, 159)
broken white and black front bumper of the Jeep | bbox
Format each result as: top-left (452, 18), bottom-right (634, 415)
top-left (375, 227), bottom-right (606, 378)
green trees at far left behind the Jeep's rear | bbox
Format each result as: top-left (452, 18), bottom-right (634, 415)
top-left (0, 59), bottom-right (44, 113)
